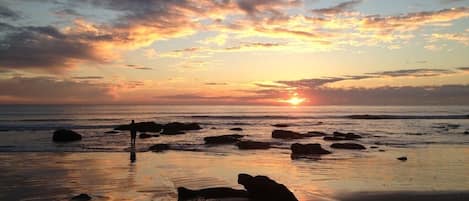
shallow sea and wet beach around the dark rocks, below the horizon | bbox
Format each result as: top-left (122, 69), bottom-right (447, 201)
top-left (0, 107), bottom-right (469, 201)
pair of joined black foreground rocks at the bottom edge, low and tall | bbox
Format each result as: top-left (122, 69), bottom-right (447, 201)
top-left (177, 174), bottom-right (298, 201)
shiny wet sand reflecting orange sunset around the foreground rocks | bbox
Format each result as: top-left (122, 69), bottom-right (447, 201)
top-left (0, 145), bottom-right (469, 201)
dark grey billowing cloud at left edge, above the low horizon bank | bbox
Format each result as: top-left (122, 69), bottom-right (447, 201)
top-left (0, 23), bottom-right (111, 73)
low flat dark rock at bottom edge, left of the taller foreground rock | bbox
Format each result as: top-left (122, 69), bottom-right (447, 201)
top-left (177, 187), bottom-right (248, 201)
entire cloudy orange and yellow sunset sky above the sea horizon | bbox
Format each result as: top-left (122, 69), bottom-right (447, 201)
top-left (0, 0), bottom-right (469, 105)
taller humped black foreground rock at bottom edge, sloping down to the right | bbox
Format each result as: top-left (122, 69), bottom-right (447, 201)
top-left (238, 174), bottom-right (298, 201)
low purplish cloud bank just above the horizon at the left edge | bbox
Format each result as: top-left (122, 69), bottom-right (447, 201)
top-left (0, 77), bottom-right (113, 103)
